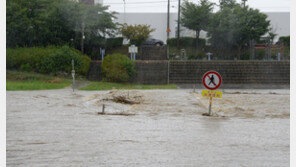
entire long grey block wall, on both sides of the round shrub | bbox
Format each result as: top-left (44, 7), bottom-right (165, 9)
top-left (89, 60), bottom-right (290, 85)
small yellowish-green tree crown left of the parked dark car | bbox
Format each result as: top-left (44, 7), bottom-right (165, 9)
top-left (121, 24), bottom-right (155, 46)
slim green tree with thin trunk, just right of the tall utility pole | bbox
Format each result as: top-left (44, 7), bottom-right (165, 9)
top-left (181, 0), bottom-right (213, 49)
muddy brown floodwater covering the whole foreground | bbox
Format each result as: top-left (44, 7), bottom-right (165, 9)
top-left (6, 88), bottom-right (290, 167)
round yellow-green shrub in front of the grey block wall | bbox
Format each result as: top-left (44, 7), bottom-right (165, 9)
top-left (102, 53), bottom-right (135, 82)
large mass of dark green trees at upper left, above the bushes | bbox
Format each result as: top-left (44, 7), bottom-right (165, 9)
top-left (6, 0), bottom-right (116, 55)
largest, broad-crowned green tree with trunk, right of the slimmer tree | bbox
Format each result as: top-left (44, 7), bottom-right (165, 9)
top-left (208, 4), bottom-right (270, 59)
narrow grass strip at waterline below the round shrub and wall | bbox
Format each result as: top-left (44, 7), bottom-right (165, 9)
top-left (80, 82), bottom-right (178, 90)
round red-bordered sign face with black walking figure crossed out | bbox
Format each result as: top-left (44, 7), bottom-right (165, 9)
top-left (202, 71), bottom-right (222, 90)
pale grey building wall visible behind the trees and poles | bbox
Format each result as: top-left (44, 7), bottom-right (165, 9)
top-left (112, 12), bottom-right (290, 42)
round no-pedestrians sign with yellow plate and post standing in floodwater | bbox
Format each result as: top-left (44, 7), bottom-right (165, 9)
top-left (202, 71), bottom-right (222, 116)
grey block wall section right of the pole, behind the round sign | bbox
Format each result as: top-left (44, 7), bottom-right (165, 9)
top-left (170, 61), bottom-right (290, 84)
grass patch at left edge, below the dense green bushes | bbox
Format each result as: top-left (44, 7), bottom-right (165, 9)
top-left (6, 71), bottom-right (71, 90)
